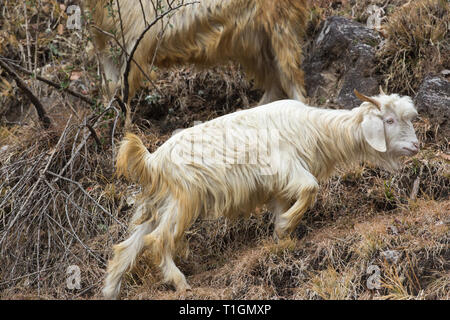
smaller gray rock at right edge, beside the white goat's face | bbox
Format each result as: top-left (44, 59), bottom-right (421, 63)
top-left (414, 75), bottom-right (450, 137)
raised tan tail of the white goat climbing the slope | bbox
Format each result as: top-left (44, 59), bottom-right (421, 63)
top-left (116, 133), bottom-right (151, 186)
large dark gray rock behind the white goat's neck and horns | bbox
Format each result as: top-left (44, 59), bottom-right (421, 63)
top-left (303, 17), bottom-right (381, 109)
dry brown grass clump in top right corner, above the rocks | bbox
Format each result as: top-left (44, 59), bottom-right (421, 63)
top-left (379, 0), bottom-right (450, 94)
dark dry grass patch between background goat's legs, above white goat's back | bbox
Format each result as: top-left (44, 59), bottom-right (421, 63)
top-left (128, 64), bottom-right (262, 134)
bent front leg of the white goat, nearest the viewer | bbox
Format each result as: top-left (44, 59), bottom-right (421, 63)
top-left (275, 178), bottom-right (319, 239)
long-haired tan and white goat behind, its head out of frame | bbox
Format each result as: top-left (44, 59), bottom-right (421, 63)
top-left (87, 0), bottom-right (308, 104)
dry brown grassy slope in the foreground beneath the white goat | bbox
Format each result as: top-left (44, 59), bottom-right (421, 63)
top-left (118, 201), bottom-right (450, 299)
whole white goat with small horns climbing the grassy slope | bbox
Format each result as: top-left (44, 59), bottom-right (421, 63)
top-left (103, 91), bottom-right (419, 298)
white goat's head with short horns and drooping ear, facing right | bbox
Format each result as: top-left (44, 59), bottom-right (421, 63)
top-left (355, 90), bottom-right (419, 165)
